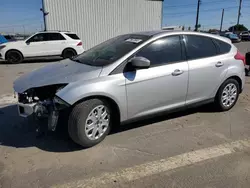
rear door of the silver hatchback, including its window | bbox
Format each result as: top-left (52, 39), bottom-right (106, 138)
top-left (185, 35), bottom-right (228, 104)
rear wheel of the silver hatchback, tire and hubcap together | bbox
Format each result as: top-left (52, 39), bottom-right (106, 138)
top-left (215, 78), bottom-right (240, 111)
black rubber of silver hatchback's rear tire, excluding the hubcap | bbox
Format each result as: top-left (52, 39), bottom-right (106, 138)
top-left (216, 79), bottom-right (240, 111)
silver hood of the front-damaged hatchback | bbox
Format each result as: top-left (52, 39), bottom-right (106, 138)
top-left (13, 59), bottom-right (102, 93)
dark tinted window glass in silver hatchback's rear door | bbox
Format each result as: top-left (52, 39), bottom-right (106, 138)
top-left (185, 35), bottom-right (217, 60)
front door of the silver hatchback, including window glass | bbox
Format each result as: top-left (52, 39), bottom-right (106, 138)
top-left (124, 35), bottom-right (188, 118)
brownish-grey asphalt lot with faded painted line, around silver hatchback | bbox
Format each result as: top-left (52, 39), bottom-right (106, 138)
top-left (0, 42), bottom-right (250, 188)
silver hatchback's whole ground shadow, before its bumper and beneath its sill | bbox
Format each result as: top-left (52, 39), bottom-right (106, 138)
top-left (0, 105), bottom-right (217, 152)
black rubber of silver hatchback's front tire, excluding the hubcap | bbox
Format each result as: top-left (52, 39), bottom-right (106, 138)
top-left (68, 99), bottom-right (112, 148)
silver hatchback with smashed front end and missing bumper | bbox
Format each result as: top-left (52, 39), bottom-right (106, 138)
top-left (14, 31), bottom-right (245, 147)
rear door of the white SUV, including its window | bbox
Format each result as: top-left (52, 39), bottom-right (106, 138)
top-left (45, 32), bottom-right (66, 56)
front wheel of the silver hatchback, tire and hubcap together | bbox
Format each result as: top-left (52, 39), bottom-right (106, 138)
top-left (68, 99), bottom-right (112, 148)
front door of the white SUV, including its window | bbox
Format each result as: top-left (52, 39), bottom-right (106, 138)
top-left (23, 33), bottom-right (48, 57)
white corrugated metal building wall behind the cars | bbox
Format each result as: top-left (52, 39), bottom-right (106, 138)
top-left (43, 0), bottom-right (163, 49)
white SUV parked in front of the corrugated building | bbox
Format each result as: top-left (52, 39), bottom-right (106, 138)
top-left (0, 31), bottom-right (84, 63)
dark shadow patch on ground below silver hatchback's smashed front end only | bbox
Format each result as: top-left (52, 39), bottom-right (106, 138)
top-left (0, 105), bottom-right (82, 152)
